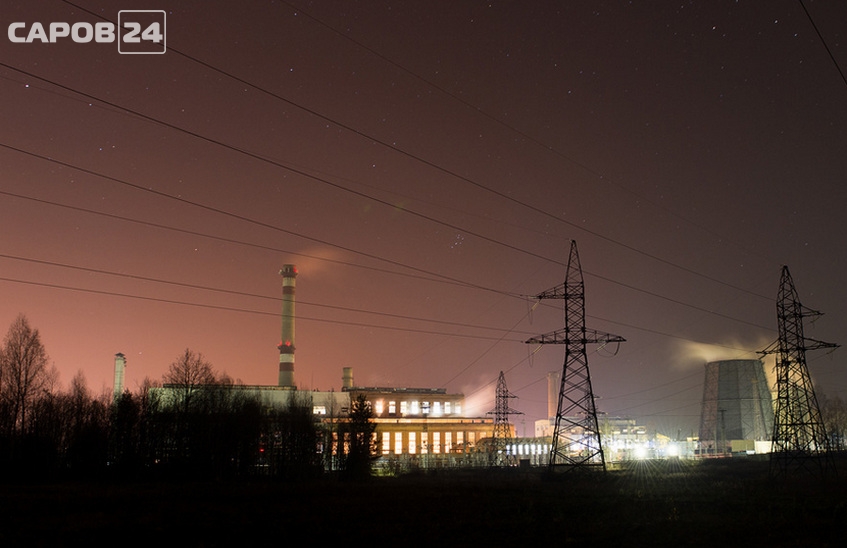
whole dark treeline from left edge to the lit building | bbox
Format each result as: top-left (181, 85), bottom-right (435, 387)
top-left (0, 315), bottom-right (370, 482)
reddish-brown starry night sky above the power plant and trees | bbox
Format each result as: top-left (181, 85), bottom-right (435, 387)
top-left (0, 0), bottom-right (847, 435)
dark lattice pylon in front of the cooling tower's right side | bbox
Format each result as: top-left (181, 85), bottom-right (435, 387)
top-left (761, 266), bottom-right (838, 477)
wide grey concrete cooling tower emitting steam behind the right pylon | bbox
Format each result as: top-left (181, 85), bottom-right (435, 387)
top-left (700, 360), bottom-right (773, 454)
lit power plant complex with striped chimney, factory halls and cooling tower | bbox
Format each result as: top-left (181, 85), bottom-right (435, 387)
top-left (114, 265), bottom-right (744, 471)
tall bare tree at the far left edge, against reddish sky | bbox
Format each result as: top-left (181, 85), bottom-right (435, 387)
top-left (0, 314), bottom-right (50, 434)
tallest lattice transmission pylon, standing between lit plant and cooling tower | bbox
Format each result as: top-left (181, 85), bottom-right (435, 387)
top-left (526, 240), bottom-right (626, 471)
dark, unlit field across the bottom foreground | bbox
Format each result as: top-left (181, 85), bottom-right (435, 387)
top-left (0, 459), bottom-right (847, 547)
